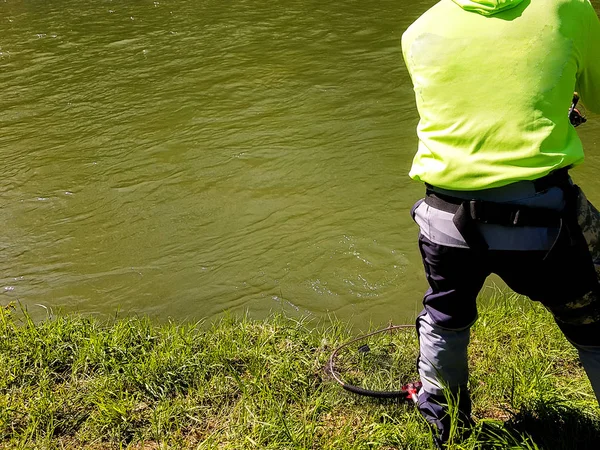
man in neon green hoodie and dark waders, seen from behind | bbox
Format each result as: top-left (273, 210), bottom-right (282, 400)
top-left (402, 0), bottom-right (600, 445)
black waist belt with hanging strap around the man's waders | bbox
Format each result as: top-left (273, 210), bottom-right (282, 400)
top-left (425, 190), bottom-right (563, 250)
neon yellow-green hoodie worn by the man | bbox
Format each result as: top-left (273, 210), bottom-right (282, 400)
top-left (402, 0), bottom-right (600, 190)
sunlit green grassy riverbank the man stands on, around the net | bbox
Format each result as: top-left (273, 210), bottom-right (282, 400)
top-left (0, 295), bottom-right (600, 450)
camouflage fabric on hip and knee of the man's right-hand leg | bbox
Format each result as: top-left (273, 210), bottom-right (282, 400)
top-left (547, 186), bottom-right (600, 326)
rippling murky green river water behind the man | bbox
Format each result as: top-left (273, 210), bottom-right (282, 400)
top-left (0, 0), bottom-right (600, 323)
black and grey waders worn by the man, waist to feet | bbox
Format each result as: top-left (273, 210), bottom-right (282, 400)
top-left (411, 169), bottom-right (600, 443)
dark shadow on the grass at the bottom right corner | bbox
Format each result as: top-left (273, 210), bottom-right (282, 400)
top-left (477, 400), bottom-right (600, 450)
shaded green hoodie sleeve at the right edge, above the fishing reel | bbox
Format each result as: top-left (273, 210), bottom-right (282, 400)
top-left (577, 1), bottom-right (600, 113)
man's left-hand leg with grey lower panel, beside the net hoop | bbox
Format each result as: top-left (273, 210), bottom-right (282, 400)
top-left (417, 236), bottom-right (489, 443)
